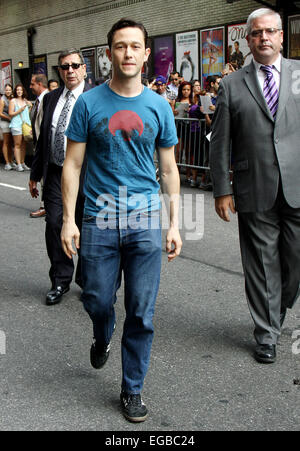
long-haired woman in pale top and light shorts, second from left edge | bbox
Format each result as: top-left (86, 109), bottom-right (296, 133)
top-left (8, 84), bottom-right (32, 172)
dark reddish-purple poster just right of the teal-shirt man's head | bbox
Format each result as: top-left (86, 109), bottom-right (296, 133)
top-left (153, 36), bottom-right (174, 80)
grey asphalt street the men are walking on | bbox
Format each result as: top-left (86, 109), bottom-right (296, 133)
top-left (0, 165), bottom-right (300, 431)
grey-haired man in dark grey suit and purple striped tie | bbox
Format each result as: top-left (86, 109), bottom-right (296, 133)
top-left (211, 8), bottom-right (300, 363)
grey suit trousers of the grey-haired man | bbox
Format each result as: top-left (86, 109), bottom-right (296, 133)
top-left (238, 186), bottom-right (300, 344)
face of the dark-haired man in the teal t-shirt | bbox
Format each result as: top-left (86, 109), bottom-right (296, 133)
top-left (107, 27), bottom-right (150, 80)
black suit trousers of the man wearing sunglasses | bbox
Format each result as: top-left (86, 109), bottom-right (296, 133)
top-left (43, 164), bottom-right (83, 287)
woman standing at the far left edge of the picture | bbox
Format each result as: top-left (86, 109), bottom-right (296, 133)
top-left (0, 83), bottom-right (16, 171)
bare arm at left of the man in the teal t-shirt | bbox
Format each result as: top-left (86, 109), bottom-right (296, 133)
top-left (61, 139), bottom-right (86, 258)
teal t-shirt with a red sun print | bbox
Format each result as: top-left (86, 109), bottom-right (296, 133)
top-left (66, 83), bottom-right (178, 221)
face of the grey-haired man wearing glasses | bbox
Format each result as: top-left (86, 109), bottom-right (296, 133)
top-left (247, 15), bottom-right (283, 64)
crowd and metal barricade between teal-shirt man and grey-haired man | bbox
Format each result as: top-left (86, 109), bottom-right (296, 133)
top-left (143, 64), bottom-right (235, 191)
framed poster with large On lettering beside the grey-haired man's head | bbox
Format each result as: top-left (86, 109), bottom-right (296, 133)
top-left (227, 23), bottom-right (253, 69)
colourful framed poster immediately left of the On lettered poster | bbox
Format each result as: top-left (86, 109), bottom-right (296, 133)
top-left (200, 27), bottom-right (225, 89)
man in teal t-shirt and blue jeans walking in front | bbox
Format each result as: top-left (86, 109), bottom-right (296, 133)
top-left (62, 19), bottom-right (182, 422)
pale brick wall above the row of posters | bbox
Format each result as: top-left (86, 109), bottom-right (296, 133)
top-left (0, 0), bottom-right (275, 81)
